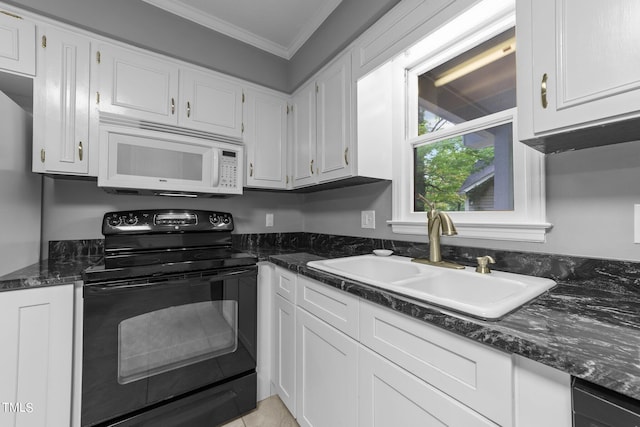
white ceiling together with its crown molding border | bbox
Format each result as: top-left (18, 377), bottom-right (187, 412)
top-left (138, 0), bottom-right (342, 59)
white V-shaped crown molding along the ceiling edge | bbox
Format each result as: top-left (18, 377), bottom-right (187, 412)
top-left (142, 0), bottom-right (342, 60)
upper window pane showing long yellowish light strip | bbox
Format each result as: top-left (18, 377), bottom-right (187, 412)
top-left (418, 28), bottom-right (516, 135)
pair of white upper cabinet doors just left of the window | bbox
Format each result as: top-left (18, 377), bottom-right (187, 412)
top-left (292, 52), bottom-right (353, 187)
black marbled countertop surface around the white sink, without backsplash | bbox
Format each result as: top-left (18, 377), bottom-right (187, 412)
top-left (258, 252), bottom-right (640, 399)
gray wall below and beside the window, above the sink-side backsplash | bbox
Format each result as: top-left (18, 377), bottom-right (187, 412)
top-left (302, 142), bottom-right (640, 261)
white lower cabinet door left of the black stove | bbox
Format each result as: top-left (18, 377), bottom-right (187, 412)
top-left (0, 284), bottom-right (73, 427)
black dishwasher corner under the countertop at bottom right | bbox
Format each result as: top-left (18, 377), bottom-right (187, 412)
top-left (571, 378), bottom-right (640, 427)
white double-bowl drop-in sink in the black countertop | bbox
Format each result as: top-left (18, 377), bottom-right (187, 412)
top-left (307, 255), bottom-right (556, 320)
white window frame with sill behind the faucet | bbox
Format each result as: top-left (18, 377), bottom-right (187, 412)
top-left (388, 0), bottom-right (551, 242)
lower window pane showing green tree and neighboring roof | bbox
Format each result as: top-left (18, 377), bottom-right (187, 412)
top-left (413, 123), bottom-right (513, 212)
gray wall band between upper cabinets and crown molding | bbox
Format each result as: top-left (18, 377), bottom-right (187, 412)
top-left (6, 0), bottom-right (399, 93)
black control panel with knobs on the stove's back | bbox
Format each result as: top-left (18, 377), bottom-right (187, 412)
top-left (102, 209), bottom-right (233, 236)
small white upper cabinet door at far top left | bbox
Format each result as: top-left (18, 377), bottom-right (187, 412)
top-left (0, 13), bottom-right (36, 76)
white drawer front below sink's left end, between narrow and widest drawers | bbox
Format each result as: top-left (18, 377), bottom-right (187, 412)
top-left (296, 276), bottom-right (359, 339)
